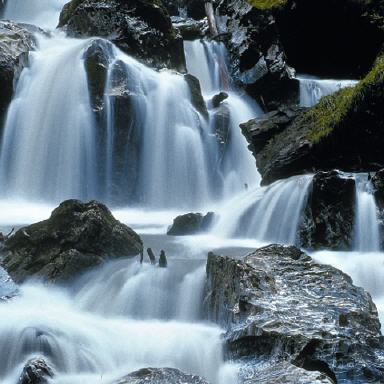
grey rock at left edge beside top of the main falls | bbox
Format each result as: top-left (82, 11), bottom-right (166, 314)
top-left (0, 21), bottom-right (37, 126)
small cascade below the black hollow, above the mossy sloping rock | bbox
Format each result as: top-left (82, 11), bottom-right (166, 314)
top-left (297, 75), bottom-right (357, 107)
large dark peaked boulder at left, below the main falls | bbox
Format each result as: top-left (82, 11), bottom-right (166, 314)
top-left (1, 200), bottom-right (143, 283)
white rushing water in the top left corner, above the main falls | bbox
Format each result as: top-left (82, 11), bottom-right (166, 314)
top-left (3, 0), bottom-right (68, 29)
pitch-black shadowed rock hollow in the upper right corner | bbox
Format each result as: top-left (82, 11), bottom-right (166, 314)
top-left (276, 0), bottom-right (384, 78)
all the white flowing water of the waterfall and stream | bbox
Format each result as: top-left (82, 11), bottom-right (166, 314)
top-left (0, 0), bottom-right (384, 384)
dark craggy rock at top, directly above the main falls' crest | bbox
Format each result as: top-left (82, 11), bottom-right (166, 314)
top-left (59, 0), bottom-right (185, 71)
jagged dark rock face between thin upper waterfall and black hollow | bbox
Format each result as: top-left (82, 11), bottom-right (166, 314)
top-left (216, 0), bottom-right (299, 110)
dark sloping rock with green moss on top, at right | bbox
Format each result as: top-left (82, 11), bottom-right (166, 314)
top-left (246, 56), bottom-right (384, 184)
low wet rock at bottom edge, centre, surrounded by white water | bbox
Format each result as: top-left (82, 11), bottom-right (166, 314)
top-left (113, 368), bottom-right (208, 384)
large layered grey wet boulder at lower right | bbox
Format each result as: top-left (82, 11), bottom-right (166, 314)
top-left (205, 245), bottom-right (384, 384)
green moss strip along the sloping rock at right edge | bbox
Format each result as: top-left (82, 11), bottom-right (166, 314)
top-left (302, 56), bottom-right (384, 143)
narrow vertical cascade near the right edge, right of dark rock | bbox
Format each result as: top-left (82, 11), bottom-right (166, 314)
top-left (354, 174), bottom-right (380, 252)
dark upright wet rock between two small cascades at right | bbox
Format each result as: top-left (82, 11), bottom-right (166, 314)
top-left (299, 171), bottom-right (356, 250)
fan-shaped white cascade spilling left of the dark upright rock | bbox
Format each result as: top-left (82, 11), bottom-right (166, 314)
top-left (212, 175), bottom-right (312, 244)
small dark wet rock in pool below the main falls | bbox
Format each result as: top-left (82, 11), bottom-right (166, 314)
top-left (167, 212), bottom-right (214, 236)
